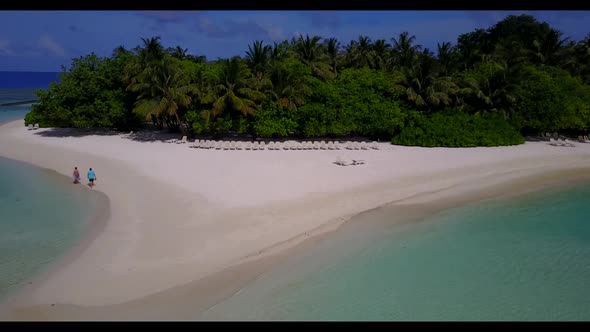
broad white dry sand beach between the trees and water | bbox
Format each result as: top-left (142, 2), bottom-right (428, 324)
top-left (0, 121), bottom-right (590, 320)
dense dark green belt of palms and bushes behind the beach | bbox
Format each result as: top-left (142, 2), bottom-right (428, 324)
top-left (25, 15), bottom-right (590, 146)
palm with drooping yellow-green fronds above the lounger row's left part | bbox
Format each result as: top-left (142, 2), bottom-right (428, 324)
top-left (212, 57), bottom-right (264, 117)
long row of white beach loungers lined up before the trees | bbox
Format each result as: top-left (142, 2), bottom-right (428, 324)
top-left (185, 140), bottom-right (379, 150)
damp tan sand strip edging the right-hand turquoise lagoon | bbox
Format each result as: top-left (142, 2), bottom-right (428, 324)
top-left (4, 167), bottom-right (590, 321)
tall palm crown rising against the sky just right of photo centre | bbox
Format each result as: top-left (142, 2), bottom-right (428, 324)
top-left (294, 35), bottom-right (333, 79)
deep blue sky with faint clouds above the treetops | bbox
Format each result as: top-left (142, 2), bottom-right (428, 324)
top-left (0, 11), bottom-right (590, 71)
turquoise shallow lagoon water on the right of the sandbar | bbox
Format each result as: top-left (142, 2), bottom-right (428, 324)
top-left (196, 185), bottom-right (590, 321)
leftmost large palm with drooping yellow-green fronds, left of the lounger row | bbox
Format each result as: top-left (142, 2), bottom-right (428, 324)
top-left (128, 61), bottom-right (198, 133)
